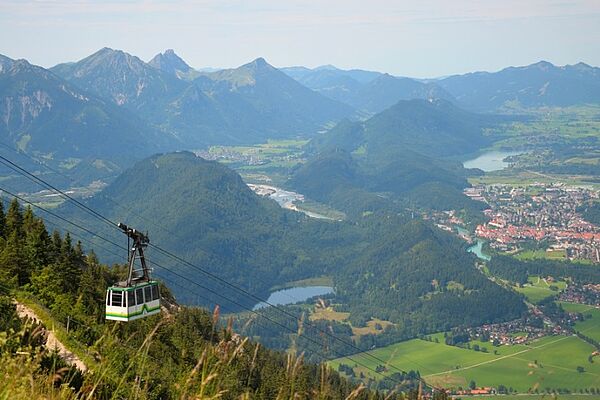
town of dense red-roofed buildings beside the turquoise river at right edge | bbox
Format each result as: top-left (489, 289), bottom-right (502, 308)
top-left (464, 183), bottom-right (600, 263)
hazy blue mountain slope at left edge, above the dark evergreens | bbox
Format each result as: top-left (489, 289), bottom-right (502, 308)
top-left (0, 56), bottom-right (169, 190)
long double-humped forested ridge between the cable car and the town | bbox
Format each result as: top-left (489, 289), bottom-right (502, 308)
top-left (64, 152), bottom-right (522, 351)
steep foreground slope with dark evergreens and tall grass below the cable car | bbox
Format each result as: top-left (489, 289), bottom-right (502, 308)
top-left (0, 201), bottom-right (408, 400)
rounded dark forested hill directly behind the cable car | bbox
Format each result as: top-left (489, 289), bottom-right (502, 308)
top-left (78, 152), bottom-right (321, 310)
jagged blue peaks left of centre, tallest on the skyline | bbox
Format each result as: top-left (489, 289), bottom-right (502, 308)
top-left (51, 48), bottom-right (353, 148)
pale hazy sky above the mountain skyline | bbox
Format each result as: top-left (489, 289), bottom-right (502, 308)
top-left (0, 0), bottom-right (600, 77)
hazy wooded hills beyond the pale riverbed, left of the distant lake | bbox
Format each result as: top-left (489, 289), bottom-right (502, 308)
top-left (289, 100), bottom-right (497, 212)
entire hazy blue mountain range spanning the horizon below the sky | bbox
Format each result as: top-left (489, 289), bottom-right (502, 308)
top-left (0, 48), bottom-right (600, 192)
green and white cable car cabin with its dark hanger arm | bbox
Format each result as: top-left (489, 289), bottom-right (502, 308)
top-left (106, 223), bottom-right (160, 321)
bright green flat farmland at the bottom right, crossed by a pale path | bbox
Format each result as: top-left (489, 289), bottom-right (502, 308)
top-left (330, 336), bottom-right (600, 393)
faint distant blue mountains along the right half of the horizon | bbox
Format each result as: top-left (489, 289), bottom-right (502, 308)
top-left (282, 61), bottom-right (600, 113)
